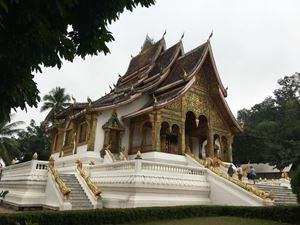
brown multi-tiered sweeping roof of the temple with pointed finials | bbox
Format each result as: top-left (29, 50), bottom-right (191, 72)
top-left (54, 37), bottom-right (241, 132)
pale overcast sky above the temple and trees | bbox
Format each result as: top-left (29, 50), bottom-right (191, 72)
top-left (14, 0), bottom-right (300, 124)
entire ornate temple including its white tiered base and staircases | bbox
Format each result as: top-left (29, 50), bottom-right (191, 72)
top-left (0, 33), bottom-right (290, 210)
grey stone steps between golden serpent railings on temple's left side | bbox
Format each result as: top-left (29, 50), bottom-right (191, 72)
top-left (59, 174), bottom-right (93, 210)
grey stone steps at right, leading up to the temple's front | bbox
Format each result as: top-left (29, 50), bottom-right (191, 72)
top-left (254, 184), bottom-right (298, 205)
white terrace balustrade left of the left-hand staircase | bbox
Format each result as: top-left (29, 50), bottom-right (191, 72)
top-left (1, 160), bottom-right (49, 180)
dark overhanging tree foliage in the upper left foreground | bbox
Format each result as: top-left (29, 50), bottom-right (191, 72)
top-left (0, 0), bottom-right (155, 121)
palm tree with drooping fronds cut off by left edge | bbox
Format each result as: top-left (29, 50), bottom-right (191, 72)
top-left (0, 118), bottom-right (24, 164)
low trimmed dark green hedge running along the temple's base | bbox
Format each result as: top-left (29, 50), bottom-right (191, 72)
top-left (0, 206), bottom-right (300, 225)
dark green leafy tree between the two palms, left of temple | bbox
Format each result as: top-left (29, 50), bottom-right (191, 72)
top-left (17, 120), bottom-right (51, 162)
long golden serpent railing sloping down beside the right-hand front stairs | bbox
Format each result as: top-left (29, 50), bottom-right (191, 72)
top-left (187, 153), bottom-right (271, 199)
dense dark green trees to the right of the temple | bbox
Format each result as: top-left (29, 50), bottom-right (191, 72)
top-left (233, 73), bottom-right (300, 169)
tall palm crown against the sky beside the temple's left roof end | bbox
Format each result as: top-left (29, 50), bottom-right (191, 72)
top-left (41, 87), bottom-right (71, 123)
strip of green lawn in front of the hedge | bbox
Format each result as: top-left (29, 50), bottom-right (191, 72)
top-left (126, 217), bottom-right (289, 225)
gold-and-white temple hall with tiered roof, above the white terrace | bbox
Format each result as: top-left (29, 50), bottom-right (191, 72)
top-left (49, 33), bottom-right (241, 162)
